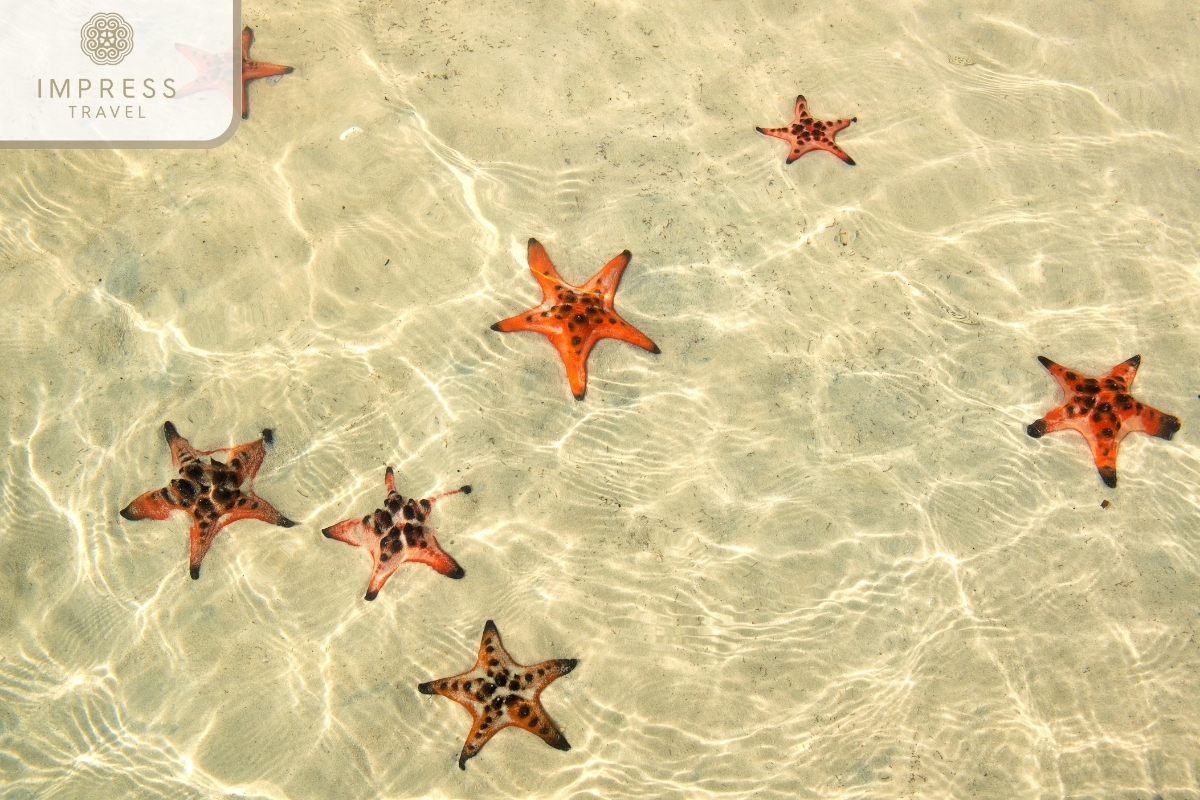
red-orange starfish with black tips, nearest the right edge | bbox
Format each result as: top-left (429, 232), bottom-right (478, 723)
top-left (1026, 355), bottom-right (1181, 488)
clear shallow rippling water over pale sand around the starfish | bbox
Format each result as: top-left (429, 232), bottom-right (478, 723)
top-left (0, 0), bottom-right (1200, 799)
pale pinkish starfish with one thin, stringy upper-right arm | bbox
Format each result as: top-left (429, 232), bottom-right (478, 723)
top-left (320, 467), bottom-right (470, 600)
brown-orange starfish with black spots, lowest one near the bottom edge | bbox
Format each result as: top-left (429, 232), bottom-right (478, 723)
top-left (416, 620), bottom-right (578, 769)
